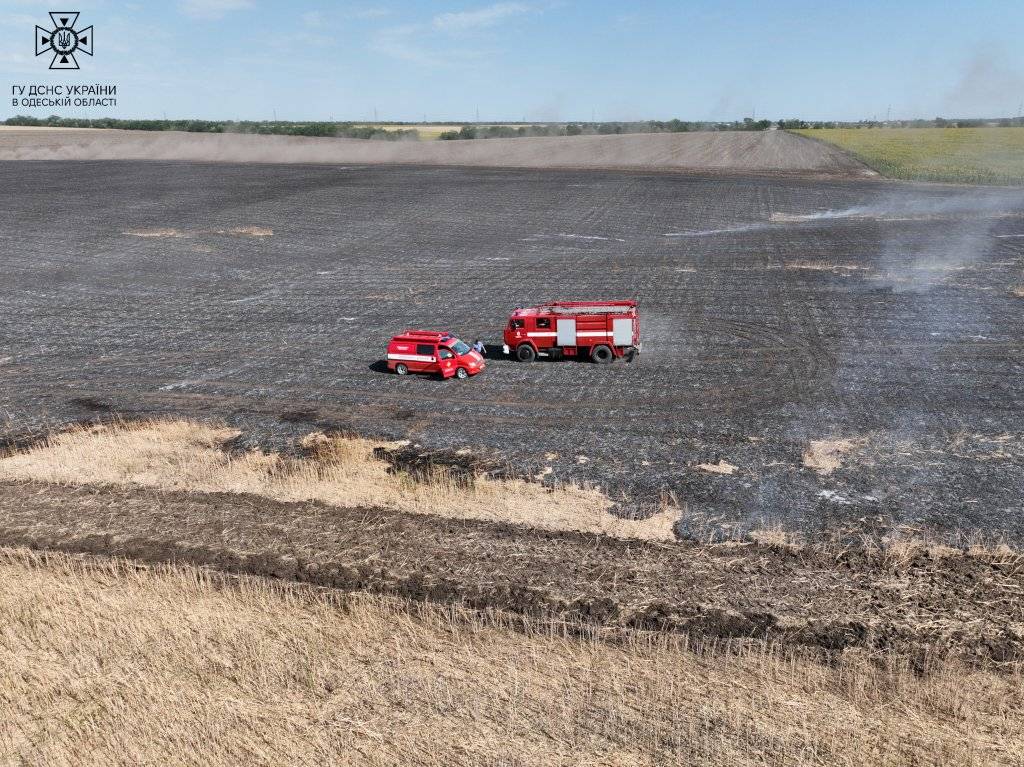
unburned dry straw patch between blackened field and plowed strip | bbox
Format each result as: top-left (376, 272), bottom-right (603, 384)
top-left (0, 421), bottom-right (678, 541)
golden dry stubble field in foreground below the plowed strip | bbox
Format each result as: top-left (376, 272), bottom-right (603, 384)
top-left (0, 550), bottom-right (1024, 767)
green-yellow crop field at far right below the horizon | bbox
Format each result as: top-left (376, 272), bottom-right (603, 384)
top-left (794, 128), bottom-right (1024, 183)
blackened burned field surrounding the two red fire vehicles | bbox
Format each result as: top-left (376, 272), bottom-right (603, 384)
top-left (0, 156), bottom-right (1024, 542)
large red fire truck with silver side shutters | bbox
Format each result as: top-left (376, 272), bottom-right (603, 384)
top-left (504, 301), bottom-right (641, 363)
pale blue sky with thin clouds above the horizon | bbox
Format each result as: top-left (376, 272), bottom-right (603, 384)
top-left (0, 0), bottom-right (1024, 122)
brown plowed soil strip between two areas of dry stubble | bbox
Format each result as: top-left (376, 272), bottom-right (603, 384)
top-left (0, 482), bottom-right (1024, 661)
